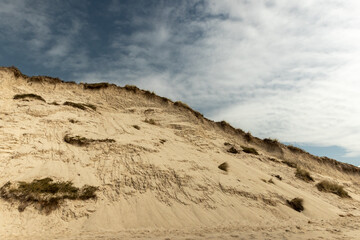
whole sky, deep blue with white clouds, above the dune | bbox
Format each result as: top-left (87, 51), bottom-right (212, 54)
top-left (0, 0), bottom-right (360, 165)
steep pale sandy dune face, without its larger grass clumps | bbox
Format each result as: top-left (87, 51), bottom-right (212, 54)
top-left (0, 68), bottom-right (360, 239)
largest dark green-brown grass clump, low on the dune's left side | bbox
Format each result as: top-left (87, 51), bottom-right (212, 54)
top-left (0, 177), bottom-right (98, 213)
